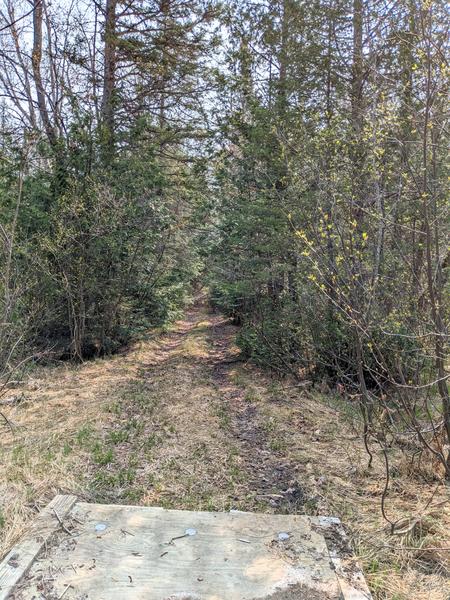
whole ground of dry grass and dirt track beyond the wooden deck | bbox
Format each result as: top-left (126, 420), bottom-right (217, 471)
top-left (0, 301), bottom-right (450, 600)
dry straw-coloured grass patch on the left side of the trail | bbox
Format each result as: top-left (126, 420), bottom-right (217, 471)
top-left (0, 342), bottom-right (135, 555)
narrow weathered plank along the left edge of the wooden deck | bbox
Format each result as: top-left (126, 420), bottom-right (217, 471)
top-left (0, 495), bottom-right (77, 600)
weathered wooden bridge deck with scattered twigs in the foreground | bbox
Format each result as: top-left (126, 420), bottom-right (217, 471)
top-left (0, 496), bottom-right (370, 600)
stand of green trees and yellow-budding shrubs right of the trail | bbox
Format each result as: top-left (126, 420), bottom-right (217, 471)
top-left (209, 2), bottom-right (448, 422)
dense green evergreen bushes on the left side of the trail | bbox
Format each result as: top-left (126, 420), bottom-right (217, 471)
top-left (0, 125), bottom-right (201, 359)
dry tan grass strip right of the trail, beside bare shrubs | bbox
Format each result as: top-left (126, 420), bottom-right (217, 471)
top-left (241, 382), bottom-right (450, 600)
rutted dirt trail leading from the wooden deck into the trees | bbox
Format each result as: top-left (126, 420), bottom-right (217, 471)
top-left (98, 302), bottom-right (304, 512)
